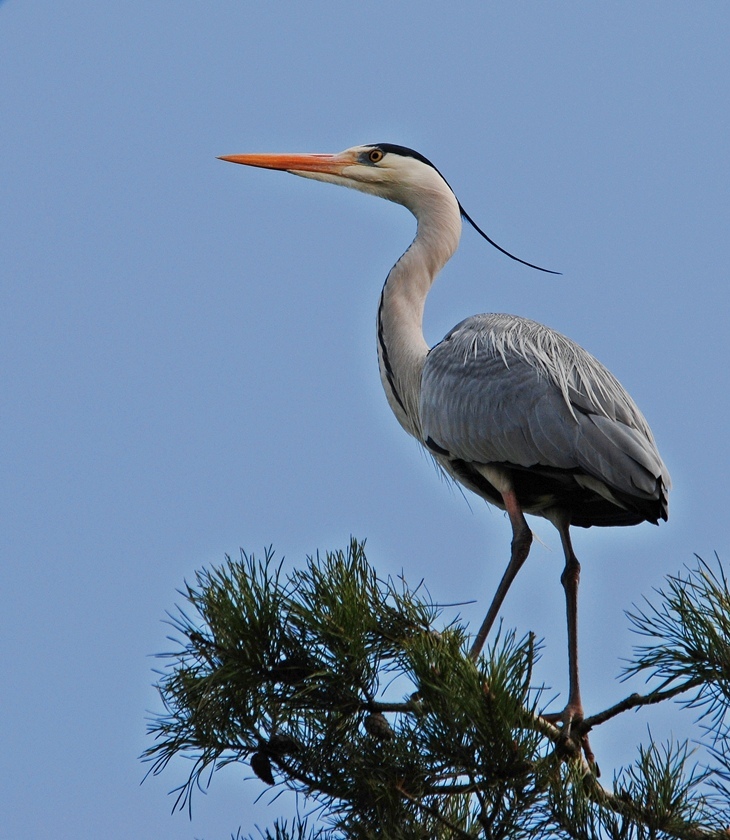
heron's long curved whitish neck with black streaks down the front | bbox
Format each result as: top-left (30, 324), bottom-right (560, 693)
top-left (378, 196), bottom-right (461, 440)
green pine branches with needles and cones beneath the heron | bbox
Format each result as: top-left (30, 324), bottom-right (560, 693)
top-left (145, 540), bottom-right (730, 840)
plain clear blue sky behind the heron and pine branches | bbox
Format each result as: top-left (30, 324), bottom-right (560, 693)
top-left (0, 0), bottom-right (730, 840)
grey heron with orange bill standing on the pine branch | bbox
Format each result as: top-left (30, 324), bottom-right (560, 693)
top-left (221, 143), bottom-right (670, 758)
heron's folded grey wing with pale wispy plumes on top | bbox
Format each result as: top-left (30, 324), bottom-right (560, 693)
top-left (420, 315), bottom-right (669, 518)
